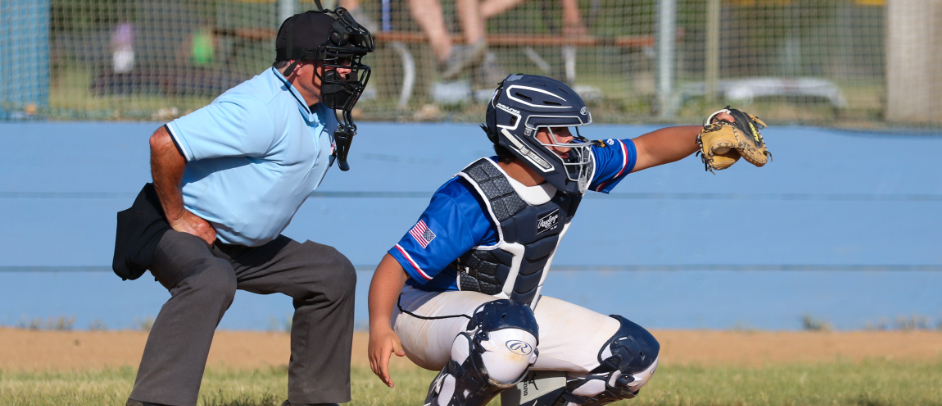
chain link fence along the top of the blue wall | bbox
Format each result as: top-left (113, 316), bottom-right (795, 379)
top-left (0, 0), bottom-right (942, 129)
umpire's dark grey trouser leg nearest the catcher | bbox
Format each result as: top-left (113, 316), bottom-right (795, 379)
top-left (227, 236), bottom-right (356, 404)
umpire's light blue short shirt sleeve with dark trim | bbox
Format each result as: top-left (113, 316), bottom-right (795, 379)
top-left (167, 98), bottom-right (275, 162)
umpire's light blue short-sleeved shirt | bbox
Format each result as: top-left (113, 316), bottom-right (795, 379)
top-left (167, 68), bottom-right (337, 246)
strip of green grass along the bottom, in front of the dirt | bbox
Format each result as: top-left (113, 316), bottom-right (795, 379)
top-left (0, 360), bottom-right (942, 406)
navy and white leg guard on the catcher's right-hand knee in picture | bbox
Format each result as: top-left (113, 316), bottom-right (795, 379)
top-left (556, 315), bottom-right (661, 406)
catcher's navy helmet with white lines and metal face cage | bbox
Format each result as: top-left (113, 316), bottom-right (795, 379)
top-left (485, 74), bottom-right (595, 194)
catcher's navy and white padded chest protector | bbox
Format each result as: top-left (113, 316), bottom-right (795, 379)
top-left (453, 158), bottom-right (582, 309)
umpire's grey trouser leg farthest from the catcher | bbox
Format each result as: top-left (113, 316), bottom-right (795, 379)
top-left (130, 231), bottom-right (236, 406)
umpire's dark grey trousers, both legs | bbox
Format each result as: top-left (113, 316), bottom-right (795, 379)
top-left (130, 231), bottom-right (356, 406)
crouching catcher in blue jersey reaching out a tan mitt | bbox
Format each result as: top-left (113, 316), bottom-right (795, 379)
top-left (369, 75), bottom-right (765, 406)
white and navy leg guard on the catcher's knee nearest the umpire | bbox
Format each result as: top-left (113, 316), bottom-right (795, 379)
top-left (425, 299), bottom-right (539, 406)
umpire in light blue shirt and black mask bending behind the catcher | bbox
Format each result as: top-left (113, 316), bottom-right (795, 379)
top-left (113, 8), bottom-right (373, 406)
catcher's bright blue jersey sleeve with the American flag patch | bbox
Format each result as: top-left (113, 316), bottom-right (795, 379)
top-left (389, 178), bottom-right (496, 290)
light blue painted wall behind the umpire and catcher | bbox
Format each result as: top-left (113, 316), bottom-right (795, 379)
top-left (0, 123), bottom-right (942, 329)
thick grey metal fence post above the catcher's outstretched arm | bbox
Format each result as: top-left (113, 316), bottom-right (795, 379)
top-left (657, 0), bottom-right (677, 118)
